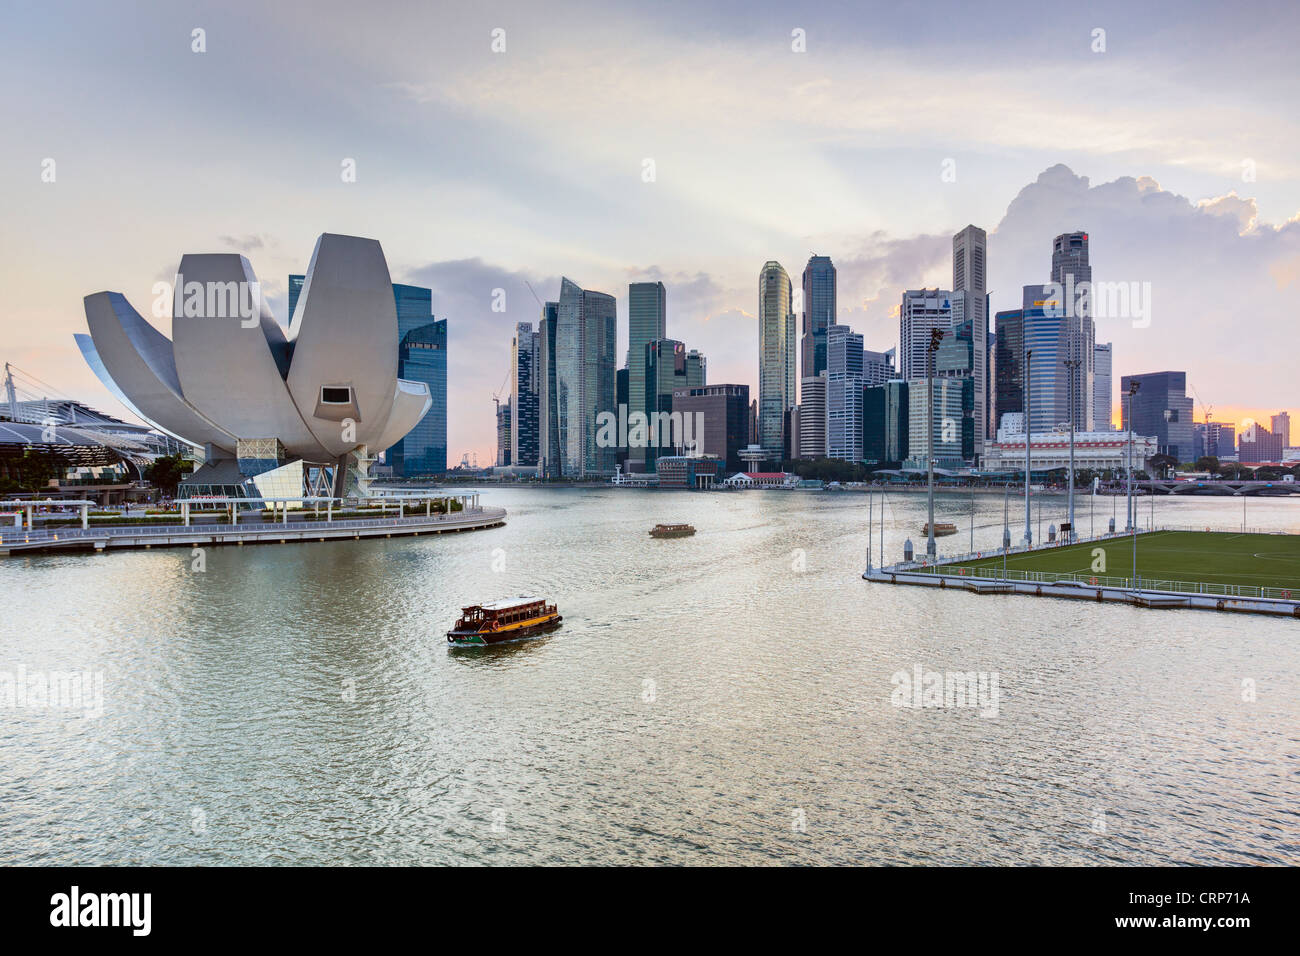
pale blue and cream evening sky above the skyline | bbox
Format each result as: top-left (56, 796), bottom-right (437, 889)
top-left (0, 0), bottom-right (1300, 463)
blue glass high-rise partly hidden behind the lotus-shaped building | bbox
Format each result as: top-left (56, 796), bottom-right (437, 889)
top-left (289, 276), bottom-right (447, 477)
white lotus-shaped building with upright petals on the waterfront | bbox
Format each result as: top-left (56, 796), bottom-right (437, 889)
top-left (77, 233), bottom-right (432, 497)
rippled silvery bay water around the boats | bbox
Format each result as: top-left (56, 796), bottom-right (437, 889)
top-left (0, 489), bottom-right (1300, 864)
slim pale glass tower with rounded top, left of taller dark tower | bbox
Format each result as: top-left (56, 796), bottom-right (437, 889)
top-left (758, 260), bottom-right (796, 458)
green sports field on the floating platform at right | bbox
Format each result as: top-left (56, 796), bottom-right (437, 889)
top-left (941, 531), bottom-right (1300, 596)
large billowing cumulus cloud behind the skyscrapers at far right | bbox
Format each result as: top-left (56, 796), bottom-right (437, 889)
top-left (988, 165), bottom-right (1300, 416)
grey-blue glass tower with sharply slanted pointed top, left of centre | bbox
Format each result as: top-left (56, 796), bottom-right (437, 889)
top-left (541, 278), bottom-right (618, 477)
